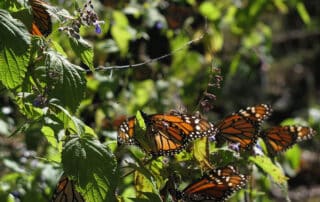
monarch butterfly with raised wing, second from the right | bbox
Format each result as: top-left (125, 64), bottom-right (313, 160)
top-left (215, 104), bottom-right (271, 149)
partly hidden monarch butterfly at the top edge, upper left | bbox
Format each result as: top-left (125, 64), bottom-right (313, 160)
top-left (29, 0), bottom-right (52, 36)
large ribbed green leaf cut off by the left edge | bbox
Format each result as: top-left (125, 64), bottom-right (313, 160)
top-left (0, 9), bottom-right (31, 89)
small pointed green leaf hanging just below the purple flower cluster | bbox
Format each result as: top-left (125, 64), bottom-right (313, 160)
top-left (69, 37), bottom-right (94, 71)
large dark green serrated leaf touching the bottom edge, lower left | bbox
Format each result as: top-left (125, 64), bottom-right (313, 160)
top-left (62, 136), bottom-right (118, 201)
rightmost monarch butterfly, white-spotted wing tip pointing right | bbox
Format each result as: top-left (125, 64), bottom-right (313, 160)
top-left (260, 126), bottom-right (316, 156)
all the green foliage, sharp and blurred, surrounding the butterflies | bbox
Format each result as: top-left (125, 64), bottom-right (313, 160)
top-left (0, 0), bottom-right (320, 201)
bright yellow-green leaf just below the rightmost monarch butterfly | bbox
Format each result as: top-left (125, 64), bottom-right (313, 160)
top-left (249, 156), bottom-right (288, 185)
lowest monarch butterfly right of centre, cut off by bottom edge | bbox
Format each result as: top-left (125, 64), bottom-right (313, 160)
top-left (173, 165), bottom-right (247, 201)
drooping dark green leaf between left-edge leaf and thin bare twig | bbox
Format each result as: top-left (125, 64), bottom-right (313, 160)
top-left (42, 51), bottom-right (86, 112)
